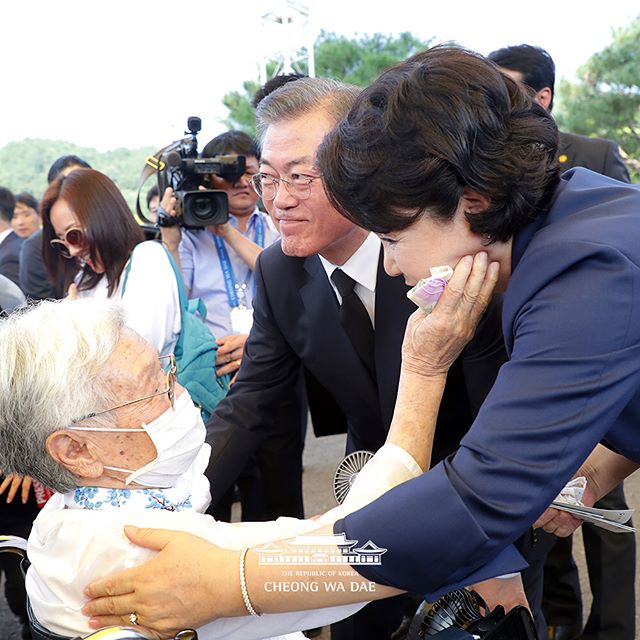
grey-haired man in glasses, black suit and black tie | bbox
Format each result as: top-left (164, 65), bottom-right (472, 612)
top-left (207, 78), bottom-right (540, 640)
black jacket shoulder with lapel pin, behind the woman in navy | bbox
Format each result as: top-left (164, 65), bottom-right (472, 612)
top-left (558, 131), bottom-right (631, 182)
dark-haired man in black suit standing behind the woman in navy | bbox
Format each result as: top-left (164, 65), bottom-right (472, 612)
top-left (488, 44), bottom-right (635, 640)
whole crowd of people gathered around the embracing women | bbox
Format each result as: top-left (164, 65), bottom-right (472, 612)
top-left (0, 45), bottom-right (640, 640)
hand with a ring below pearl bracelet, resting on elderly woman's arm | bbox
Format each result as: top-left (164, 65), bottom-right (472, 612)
top-left (82, 527), bottom-right (242, 638)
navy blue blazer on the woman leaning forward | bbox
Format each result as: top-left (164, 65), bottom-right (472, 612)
top-left (335, 169), bottom-right (640, 596)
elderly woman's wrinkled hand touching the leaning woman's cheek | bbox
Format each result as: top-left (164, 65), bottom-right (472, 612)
top-left (402, 251), bottom-right (499, 376)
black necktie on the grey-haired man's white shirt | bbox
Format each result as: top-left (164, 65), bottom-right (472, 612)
top-left (331, 269), bottom-right (375, 378)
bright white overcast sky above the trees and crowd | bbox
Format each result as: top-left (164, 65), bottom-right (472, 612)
top-left (0, 0), bottom-right (640, 150)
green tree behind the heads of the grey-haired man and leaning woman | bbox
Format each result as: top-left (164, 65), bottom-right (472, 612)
top-left (222, 31), bottom-right (430, 135)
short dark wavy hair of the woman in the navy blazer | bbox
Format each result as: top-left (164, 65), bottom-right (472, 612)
top-left (318, 45), bottom-right (559, 241)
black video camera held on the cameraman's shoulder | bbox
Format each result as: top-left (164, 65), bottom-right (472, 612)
top-left (138, 116), bottom-right (245, 228)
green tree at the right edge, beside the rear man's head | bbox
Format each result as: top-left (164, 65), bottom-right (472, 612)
top-left (554, 16), bottom-right (640, 181)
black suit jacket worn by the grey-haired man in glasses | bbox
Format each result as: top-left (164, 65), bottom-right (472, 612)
top-left (207, 243), bottom-right (506, 502)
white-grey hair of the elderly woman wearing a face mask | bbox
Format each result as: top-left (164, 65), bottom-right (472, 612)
top-left (0, 299), bottom-right (124, 492)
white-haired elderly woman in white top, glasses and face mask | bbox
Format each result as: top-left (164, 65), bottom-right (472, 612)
top-left (0, 300), bottom-right (433, 640)
